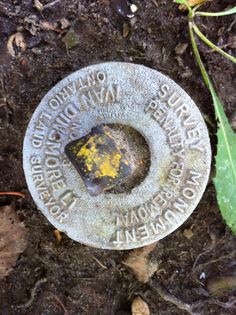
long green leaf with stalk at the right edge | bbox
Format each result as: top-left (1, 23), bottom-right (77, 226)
top-left (189, 22), bottom-right (236, 234)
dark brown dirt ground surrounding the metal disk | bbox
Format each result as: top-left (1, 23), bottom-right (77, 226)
top-left (0, 0), bottom-right (236, 315)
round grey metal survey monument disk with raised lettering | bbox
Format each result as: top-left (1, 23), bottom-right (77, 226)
top-left (23, 62), bottom-right (211, 249)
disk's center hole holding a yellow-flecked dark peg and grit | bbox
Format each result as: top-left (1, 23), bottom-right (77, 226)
top-left (65, 124), bottom-right (150, 196)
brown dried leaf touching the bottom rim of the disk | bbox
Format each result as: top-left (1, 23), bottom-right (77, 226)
top-left (123, 243), bottom-right (158, 283)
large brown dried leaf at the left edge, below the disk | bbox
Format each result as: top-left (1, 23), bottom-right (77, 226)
top-left (0, 206), bottom-right (27, 279)
